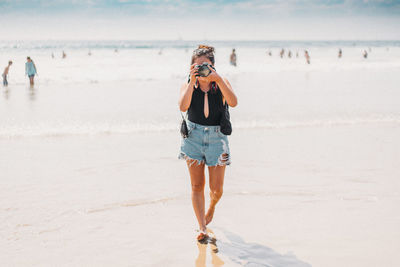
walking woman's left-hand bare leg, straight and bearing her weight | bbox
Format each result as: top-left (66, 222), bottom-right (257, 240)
top-left (186, 159), bottom-right (206, 231)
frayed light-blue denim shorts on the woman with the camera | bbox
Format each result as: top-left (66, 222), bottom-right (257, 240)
top-left (179, 120), bottom-right (231, 166)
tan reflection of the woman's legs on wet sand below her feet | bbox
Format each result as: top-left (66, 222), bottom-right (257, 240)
top-left (195, 229), bottom-right (225, 267)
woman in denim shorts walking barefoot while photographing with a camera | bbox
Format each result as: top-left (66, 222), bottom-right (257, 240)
top-left (179, 45), bottom-right (237, 241)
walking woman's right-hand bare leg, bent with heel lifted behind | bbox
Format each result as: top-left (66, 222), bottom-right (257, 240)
top-left (206, 165), bottom-right (225, 225)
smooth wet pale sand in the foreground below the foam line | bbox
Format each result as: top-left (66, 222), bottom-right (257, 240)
top-left (0, 124), bottom-right (400, 267)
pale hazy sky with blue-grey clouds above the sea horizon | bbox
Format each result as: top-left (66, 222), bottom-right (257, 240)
top-left (0, 0), bottom-right (400, 40)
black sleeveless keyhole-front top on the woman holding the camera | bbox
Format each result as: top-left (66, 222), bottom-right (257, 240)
top-left (188, 83), bottom-right (223, 126)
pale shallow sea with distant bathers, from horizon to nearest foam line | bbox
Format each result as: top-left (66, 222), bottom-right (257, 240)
top-left (0, 41), bottom-right (400, 138)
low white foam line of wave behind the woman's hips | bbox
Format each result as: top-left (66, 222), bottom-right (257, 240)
top-left (0, 118), bottom-right (400, 139)
